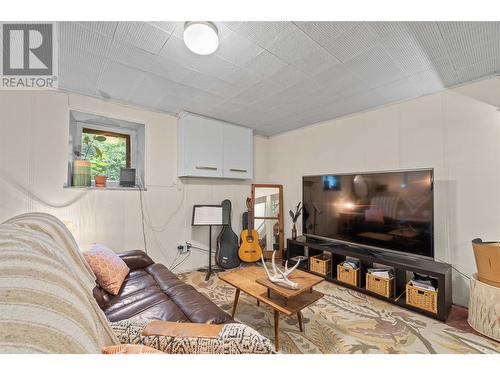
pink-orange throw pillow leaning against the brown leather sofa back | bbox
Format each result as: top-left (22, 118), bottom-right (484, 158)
top-left (83, 244), bottom-right (130, 296)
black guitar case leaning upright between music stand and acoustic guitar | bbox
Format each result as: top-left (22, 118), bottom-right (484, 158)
top-left (215, 199), bottom-right (240, 269)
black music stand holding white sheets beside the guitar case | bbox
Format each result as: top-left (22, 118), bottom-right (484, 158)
top-left (191, 204), bottom-right (228, 281)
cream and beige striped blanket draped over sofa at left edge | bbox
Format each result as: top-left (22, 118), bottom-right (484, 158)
top-left (0, 213), bottom-right (119, 353)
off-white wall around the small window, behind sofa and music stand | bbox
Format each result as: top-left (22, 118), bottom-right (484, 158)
top-left (0, 91), bottom-right (268, 271)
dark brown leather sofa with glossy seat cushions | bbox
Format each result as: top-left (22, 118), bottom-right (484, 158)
top-left (94, 250), bottom-right (234, 324)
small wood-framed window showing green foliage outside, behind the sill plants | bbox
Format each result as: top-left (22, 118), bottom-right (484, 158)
top-left (81, 128), bottom-right (130, 181)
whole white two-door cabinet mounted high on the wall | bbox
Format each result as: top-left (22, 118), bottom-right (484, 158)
top-left (177, 113), bottom-right (253, 179)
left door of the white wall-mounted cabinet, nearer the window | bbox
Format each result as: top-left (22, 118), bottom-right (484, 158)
top-left (178, 115), bottom-right (223, 177)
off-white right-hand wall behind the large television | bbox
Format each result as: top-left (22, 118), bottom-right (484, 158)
top-left (268, 79), bottom-right (500, 305)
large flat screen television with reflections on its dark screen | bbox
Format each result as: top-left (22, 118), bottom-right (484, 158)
top-left (302, 169), bottom-right (434, 257)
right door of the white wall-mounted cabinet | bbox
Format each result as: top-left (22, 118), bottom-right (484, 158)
top-left (223, 124), bottom-right (253, 179)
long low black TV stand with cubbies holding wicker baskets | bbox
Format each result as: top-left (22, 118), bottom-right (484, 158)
top-left (286, 237), bottom-right (452, 321)
